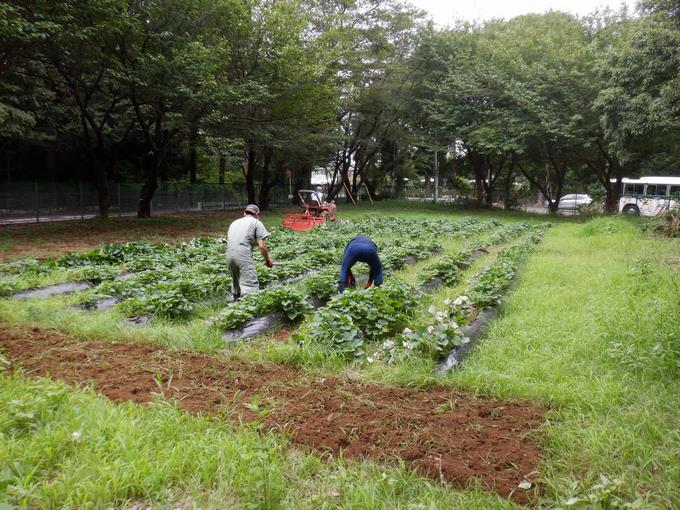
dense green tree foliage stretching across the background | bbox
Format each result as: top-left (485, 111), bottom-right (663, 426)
top-left (0, 0), bottom-right (680, 216)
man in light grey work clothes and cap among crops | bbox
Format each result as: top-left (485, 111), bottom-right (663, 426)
top-left (227, 204), bottom-right (274, 301)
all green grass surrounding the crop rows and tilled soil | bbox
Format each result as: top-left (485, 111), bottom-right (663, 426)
top-left (0, 203), bottom-right (680, 509)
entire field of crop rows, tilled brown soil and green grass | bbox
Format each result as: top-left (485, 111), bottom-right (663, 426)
top-left (0, 211), bottom-right (680, 509)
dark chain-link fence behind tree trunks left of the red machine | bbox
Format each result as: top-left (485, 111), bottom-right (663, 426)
top-left (0, 181), bottom-right (290, 224)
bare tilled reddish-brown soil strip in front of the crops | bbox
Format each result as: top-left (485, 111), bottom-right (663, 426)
top-left (0, 323), bottom-right (545, 503)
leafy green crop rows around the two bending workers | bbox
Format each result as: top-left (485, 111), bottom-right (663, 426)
top-left (0, 217), bottom-right (544, 362)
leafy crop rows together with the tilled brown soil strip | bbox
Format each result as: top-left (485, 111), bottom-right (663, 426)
top-left (0, 213), bottom-right (546, 508)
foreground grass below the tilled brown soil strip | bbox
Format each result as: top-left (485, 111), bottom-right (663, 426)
top-left (0, 375), bottom-right (512, 510)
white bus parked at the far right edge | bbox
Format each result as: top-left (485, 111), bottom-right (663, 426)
top-left (619, 177), bottom-right (680, 216)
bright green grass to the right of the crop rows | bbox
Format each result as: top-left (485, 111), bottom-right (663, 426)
top-left (448, 218), bottom-right (680, 508)
